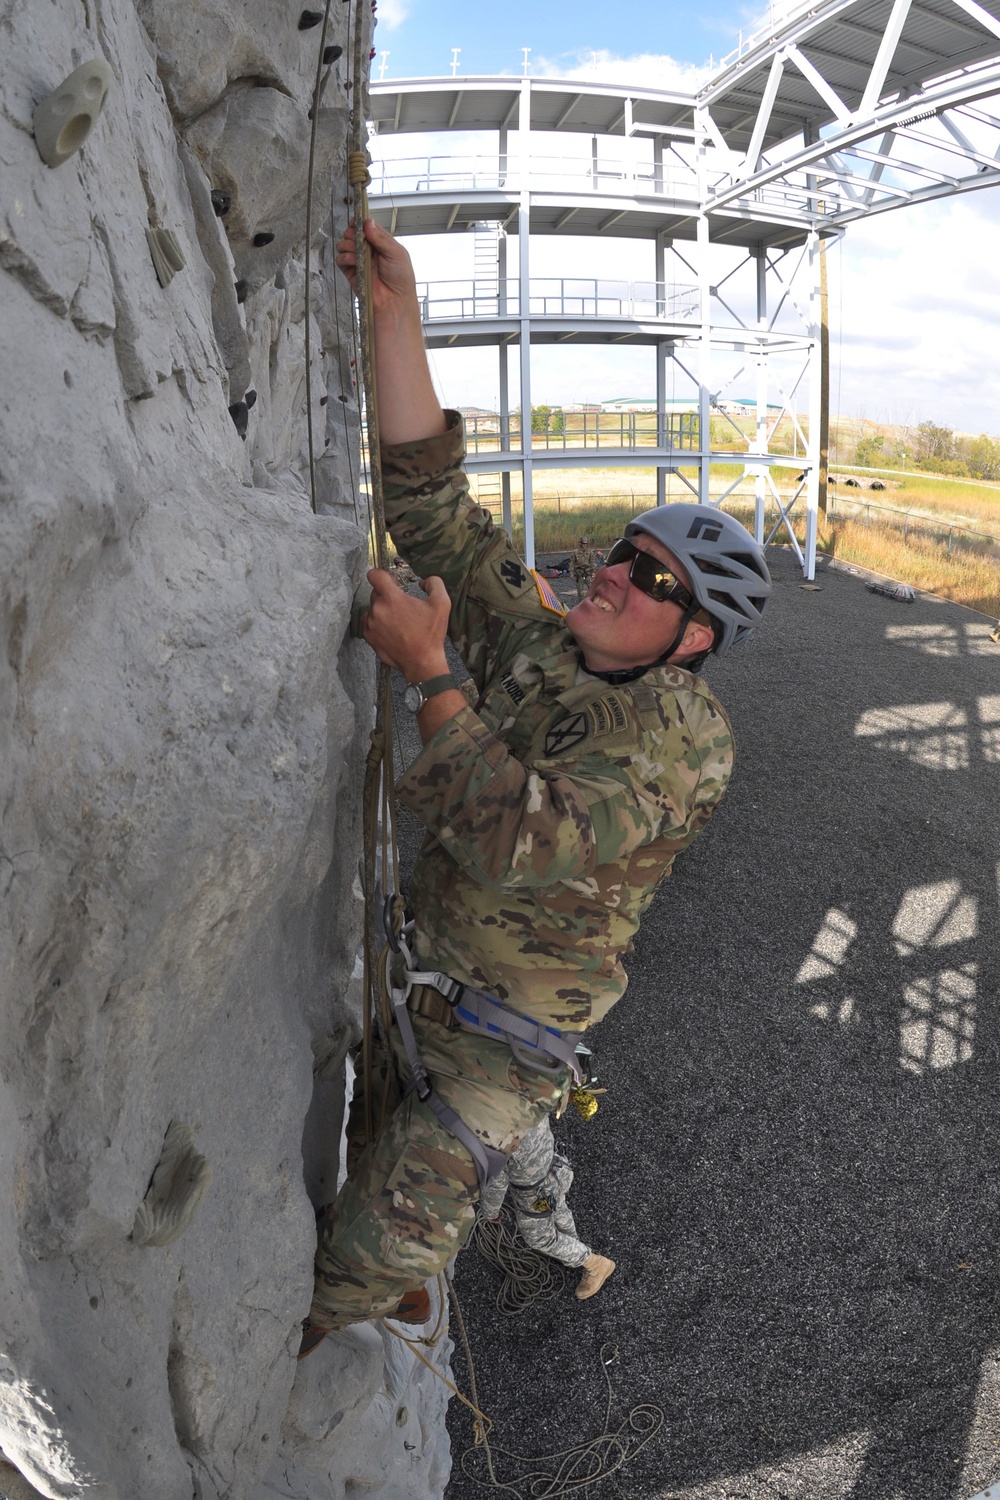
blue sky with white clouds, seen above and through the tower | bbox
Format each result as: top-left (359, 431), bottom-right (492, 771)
top-left (372, 0), bottom-right (1000, 435)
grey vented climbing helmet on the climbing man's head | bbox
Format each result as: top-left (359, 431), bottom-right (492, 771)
top-left (625, 503), bottom-right (771, 656)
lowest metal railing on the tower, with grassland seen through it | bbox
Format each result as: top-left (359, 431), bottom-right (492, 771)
top-left (465, 410), bottom-right (699, 453)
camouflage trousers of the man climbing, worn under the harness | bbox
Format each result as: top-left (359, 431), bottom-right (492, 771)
top-left (309, 996), bottom-right (570, 1328)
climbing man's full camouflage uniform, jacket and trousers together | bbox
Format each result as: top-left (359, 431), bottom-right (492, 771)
top-left (310, 414), bottom-right (733, 1328)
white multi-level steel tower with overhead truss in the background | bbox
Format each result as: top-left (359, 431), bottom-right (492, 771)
top-left (370, 0), bottom-right (1000, 578)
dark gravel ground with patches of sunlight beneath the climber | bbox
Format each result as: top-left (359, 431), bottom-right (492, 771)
top-left (392, 549), bottom-right (1000, 1500)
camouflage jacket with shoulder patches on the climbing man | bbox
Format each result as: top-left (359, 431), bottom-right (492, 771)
top-left (382, 413), bottom-right (733, 1031)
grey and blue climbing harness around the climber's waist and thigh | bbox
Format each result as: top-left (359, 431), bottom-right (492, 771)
top-left (382, 900), bottom-right (582, 1193)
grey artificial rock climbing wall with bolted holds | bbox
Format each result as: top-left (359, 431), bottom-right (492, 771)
top-left (0, 0), bottom-right (448, 1500)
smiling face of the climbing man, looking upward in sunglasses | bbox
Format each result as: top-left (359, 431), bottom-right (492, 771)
top-left (567, 533), bottom-right (688, 672)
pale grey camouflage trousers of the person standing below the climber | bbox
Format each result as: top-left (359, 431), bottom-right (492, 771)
top-left (480, 1116), bottom-right (591, 1266)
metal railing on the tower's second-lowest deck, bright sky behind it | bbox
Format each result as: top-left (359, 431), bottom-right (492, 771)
top-left (417, 276), bottom-right (699, 323)
